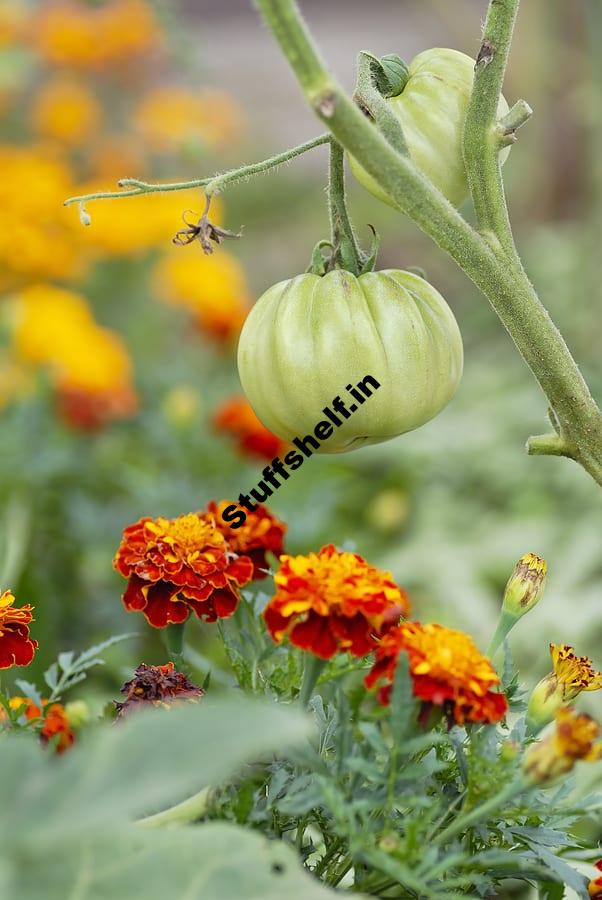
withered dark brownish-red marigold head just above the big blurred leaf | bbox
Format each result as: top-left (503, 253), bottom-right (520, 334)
top-left (115, 662), bottom-right (205, 718)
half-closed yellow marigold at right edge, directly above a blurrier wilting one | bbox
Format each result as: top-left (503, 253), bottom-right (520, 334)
top-left (527, 644), bottom-right (602, 729)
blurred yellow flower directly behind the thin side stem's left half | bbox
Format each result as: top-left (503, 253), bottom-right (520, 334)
top-left (70, 181), bottom-right (215, 256)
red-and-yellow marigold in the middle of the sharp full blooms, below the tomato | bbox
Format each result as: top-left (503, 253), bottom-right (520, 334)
top-left (263, 544), bottom-right (409, 659)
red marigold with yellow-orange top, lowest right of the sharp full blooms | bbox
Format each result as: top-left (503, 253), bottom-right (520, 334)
top-left (365, 622), bottom-right (508, 725)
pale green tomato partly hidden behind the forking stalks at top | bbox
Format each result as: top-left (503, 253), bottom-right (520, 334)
top-left (350, 48), bottom-right (510, 206)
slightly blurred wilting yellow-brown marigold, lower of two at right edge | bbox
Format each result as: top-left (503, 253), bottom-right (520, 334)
top-left (523, 706), bottom-right (602, 784)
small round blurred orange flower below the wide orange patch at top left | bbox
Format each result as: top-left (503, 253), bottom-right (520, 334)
top-left (32, 76), bottom-right (102, 147)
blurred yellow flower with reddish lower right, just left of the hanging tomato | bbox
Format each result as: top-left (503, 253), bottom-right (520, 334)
top-left (153, 247), bottom-right (251, 340)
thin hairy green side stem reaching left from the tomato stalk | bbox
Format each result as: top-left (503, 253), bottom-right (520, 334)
top-left (63, 134), bottom-right (331, 206)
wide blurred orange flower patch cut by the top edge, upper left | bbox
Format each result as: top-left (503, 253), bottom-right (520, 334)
top-left (31, 0), bottom-right (160, 68)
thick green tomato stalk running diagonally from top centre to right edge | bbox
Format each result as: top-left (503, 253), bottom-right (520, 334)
top-left (255, 0), bottom-right (602, 485)
